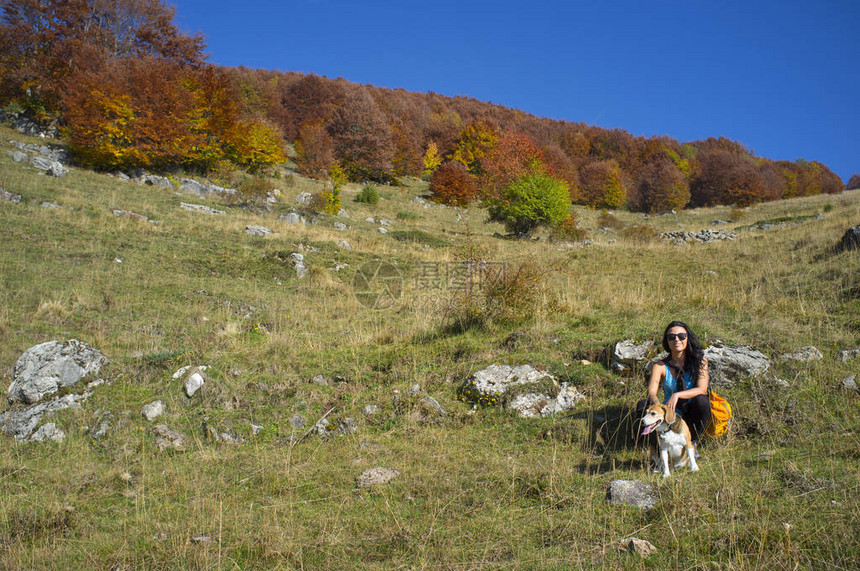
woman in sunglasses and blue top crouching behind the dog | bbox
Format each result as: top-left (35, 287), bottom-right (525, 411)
top-left (640, 321), bottom-right (711, 445)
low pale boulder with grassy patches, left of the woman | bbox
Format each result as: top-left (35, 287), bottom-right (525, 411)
top-left (460, 365), bottom-right (585, 418)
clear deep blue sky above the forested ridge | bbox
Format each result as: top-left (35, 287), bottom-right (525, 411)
top-left (174, 0), bottom-right (860, 180)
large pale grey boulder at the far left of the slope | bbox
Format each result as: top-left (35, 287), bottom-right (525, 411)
top-left (7, 339), bottom-right (107, 404)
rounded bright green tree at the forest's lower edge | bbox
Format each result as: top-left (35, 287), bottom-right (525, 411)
top-left (488, 166), bottom-right (570, 236)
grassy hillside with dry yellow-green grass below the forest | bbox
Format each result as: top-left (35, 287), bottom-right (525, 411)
top-left (0, 128), bottom-right (860, 569)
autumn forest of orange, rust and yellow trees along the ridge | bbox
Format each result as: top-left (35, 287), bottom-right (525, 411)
top-left (0, 0), bottom-right (844, 212)
